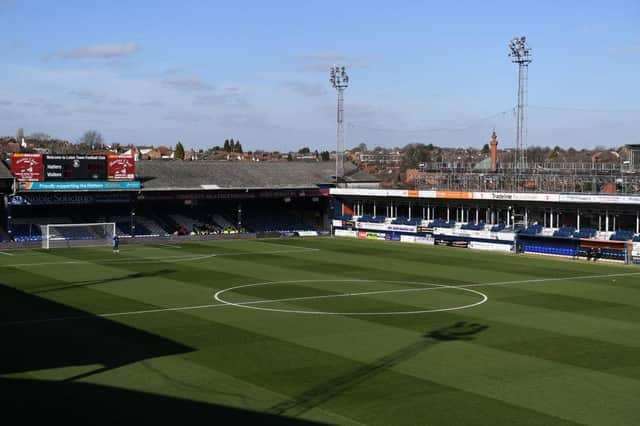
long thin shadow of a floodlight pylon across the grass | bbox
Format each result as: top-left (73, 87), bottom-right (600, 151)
top-left (270, 321), bottom-right (488, 417)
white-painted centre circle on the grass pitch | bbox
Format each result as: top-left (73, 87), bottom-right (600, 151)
top-left (213, 279), bottom-right (489, 316)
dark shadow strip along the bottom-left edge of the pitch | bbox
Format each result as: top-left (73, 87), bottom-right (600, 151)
top-left (0, 377), bottom-right (320, 426)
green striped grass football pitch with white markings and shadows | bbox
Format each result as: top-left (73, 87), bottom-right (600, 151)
top-left (0, 237), bottom-right (640, 425)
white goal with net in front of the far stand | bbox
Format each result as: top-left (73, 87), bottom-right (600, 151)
top-left (41, 222), bottom-right (116, 249)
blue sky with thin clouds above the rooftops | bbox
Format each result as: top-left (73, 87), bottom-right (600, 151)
top-left (0, 0), bottom-right (640, 151)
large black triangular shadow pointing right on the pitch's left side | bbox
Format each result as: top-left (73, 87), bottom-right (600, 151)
top-left (0, 284), bottom-right (193, 380)
